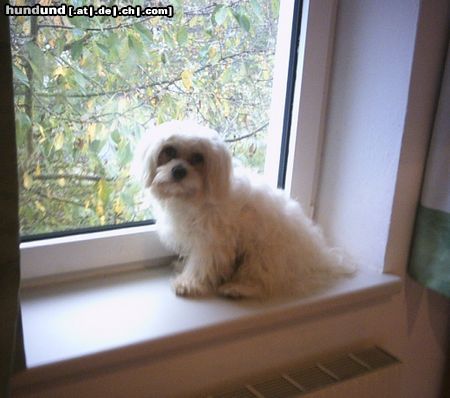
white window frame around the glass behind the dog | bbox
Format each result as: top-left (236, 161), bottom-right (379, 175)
top-left (20, 0), bottom-right (337, 286)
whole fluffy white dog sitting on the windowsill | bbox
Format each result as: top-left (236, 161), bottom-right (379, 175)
top-left (139, 121), bottom-right (352, 298)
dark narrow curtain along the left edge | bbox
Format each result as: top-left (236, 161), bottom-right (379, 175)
top-left (0, 12), bottom-right (24, 397)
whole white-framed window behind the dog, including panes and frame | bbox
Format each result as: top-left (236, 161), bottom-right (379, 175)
top-left (11, 0), bottom-right (334, 279)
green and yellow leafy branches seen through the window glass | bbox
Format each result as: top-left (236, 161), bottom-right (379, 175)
top-left (10, 0), bottom-right (279, 235)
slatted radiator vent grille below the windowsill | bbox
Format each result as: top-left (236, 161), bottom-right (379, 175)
top-left (208, 347), bottom-right (399, 398)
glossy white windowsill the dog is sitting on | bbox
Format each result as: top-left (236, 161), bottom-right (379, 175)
top-left (14, 262), bottom-right (401, 388)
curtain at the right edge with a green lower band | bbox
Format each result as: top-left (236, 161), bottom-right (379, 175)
top-left (408, 42), bottom-right (450, 298)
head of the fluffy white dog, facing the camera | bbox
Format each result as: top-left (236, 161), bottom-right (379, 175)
top-left (138, 121), bottom-right (231, 202)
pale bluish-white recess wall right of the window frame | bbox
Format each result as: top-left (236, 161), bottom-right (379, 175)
top-left (316, 0), bottom-right (420, 269)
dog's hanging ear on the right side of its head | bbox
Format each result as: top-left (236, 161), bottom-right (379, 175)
top-left (205, 139), bottom-right (231, 201)
